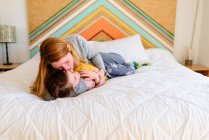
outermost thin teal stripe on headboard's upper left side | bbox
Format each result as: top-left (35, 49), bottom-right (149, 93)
top-left (29, 0), bottom-right (79, 39)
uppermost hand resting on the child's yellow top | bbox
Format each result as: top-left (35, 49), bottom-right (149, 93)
top-left (79, 70), bottom-right (99, 84)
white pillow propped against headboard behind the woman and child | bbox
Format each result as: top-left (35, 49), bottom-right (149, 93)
top-left (89, 34), bottom-right (149, 63)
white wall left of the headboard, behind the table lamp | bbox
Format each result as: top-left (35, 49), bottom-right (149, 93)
top-left (0, 0), bottom-right (29, 64)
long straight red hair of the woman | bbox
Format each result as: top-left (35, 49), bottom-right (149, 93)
top-left (31, 38), bottom-right (81, 97)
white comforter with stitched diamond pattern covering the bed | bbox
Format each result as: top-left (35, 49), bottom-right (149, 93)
top-left (0, 49), bottom-right (209, 140)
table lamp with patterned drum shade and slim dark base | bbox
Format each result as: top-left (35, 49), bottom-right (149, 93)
top-left (0, 25), bottom-right (16, 65)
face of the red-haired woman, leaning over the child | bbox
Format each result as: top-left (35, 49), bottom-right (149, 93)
top-left (51, 53), bottom-right (74, 72)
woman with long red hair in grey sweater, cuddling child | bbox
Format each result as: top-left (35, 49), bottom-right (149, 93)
top-left (31, 35), bottom-right (105, 98)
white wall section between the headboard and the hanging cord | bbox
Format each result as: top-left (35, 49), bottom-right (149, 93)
top-left (174, 0), bottom-right (200, 64)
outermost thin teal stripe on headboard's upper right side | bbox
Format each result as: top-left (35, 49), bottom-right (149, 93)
top-left (123, 0), bottom-right (174, 40)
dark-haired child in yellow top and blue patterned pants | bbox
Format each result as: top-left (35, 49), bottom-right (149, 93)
top-left (46, 53), bottom-right (135, 99)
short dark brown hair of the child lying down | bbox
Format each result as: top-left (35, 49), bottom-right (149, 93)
top-left (46, 70), bottom-right (78, 99)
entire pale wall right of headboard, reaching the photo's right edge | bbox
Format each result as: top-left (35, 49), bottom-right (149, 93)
top-left (174, 0), bottom-right (209, 67)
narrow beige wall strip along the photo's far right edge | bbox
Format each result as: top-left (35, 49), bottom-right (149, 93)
top-left (197, 0), bottom-right (209, 67)
